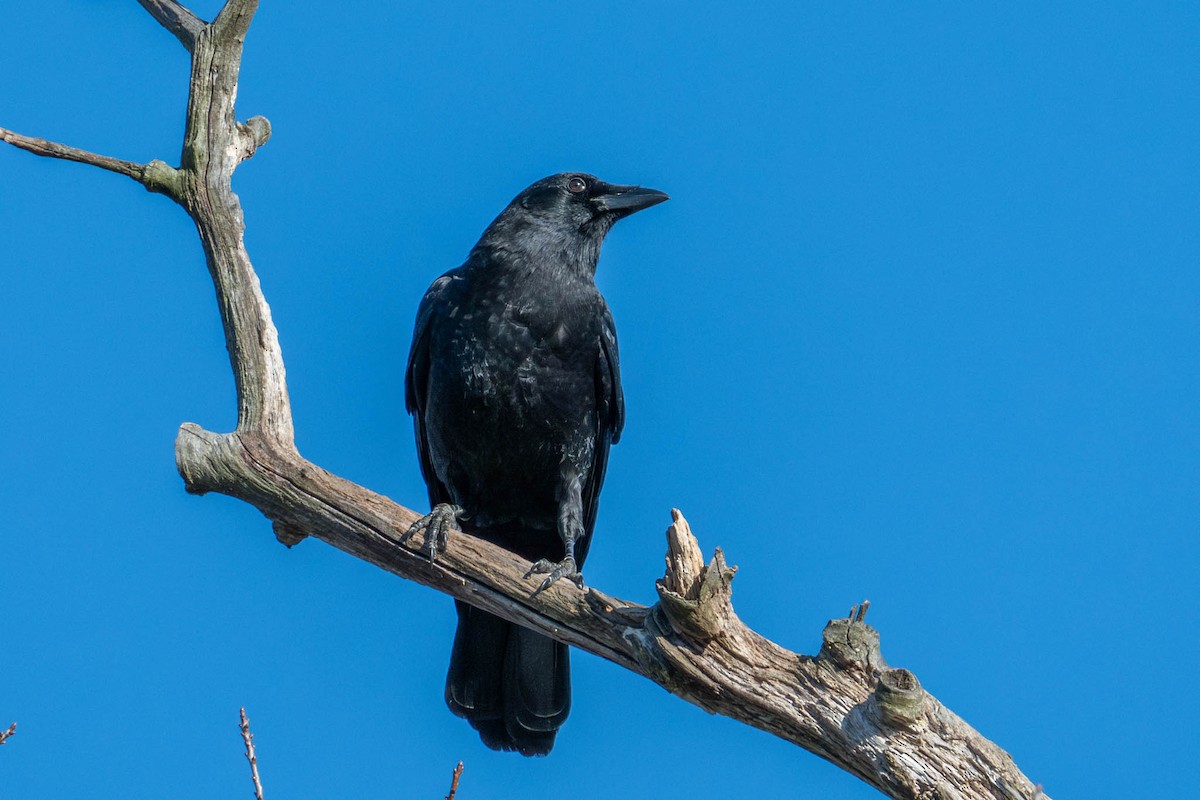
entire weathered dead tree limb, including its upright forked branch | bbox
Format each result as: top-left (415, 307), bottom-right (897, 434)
top-left (0, 0), bottom-right (1045, 800)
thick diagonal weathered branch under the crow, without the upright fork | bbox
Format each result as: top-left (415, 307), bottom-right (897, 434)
top-left (175, 425), bottom-right (1033, 800)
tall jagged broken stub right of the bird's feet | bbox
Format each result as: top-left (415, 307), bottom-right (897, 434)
top-left (656, 509), bottom-right (737, 643)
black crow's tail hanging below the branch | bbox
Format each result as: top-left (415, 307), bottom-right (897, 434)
top-left (446, 601), bottom-right (571, 756)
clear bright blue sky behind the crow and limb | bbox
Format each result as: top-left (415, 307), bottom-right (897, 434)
top-left (0, 0), bottom-right (1200, 800)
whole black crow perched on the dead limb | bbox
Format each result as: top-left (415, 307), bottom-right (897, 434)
top-left (404, 173), bottom-right (667, 756)
